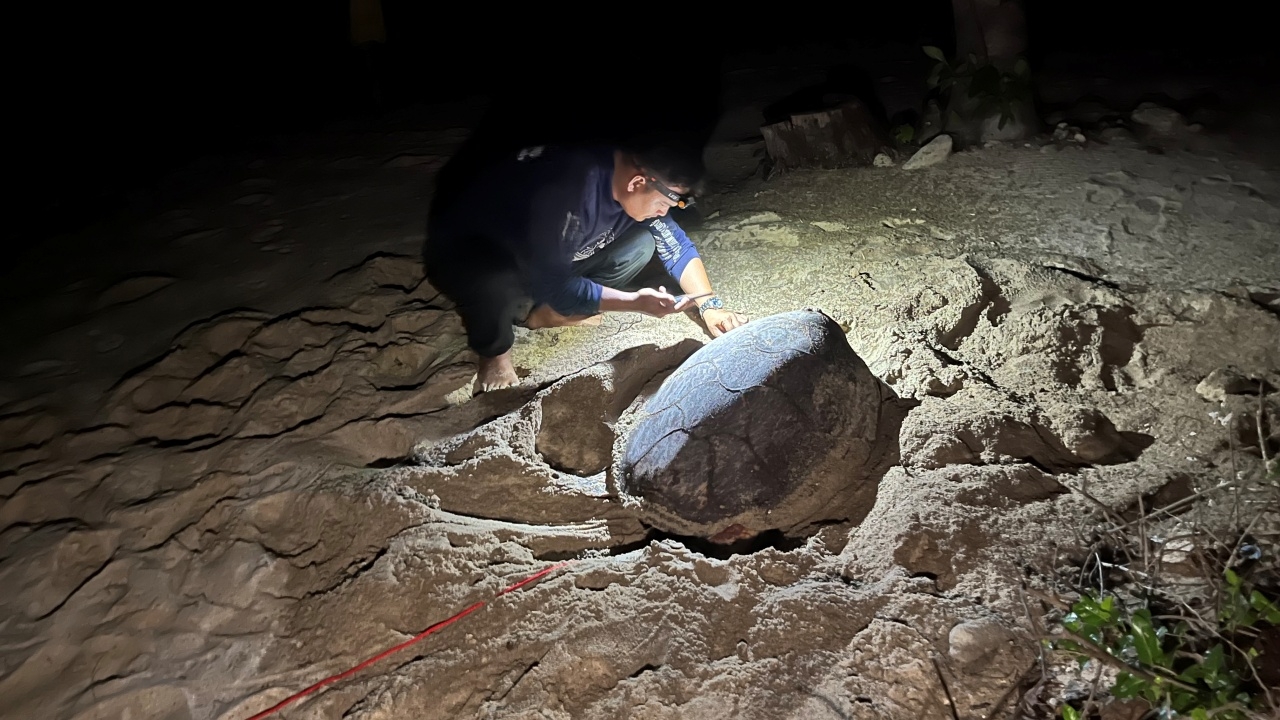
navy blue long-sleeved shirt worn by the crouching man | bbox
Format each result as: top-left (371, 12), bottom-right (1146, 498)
top-left (442, 146), bottom-right (698, 315)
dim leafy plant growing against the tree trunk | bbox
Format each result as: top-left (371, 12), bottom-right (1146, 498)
top-left (924, 45), bottom-right (1032, 128)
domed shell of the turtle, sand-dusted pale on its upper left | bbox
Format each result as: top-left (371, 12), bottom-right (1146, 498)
top-left (620, 310), bottom-right (874, 524)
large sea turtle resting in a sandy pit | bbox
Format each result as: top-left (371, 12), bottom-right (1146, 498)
top-left (613, 310), bottom-right (884, 542)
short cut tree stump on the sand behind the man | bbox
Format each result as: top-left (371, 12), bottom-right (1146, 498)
top-left (760, 100), bottom-right (888, 169)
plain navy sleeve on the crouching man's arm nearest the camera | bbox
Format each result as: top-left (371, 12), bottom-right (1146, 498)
top-left (524, 183), bottom-right (602, 315)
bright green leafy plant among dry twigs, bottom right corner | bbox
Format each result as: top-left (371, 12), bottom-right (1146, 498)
top-left (1048, 569), bottom-right (1280, 720)
